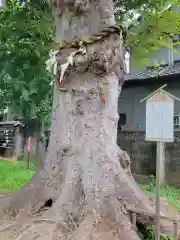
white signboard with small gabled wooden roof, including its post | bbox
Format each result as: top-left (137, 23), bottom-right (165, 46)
top-left (140, 84), bottom-right (180, 240)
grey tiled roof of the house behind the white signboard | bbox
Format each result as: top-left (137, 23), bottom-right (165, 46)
top-left (125, 62), bottom-right (180, 80)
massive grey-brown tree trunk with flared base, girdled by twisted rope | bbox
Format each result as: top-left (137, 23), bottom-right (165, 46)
top-left (0, 0), bottom-right (167, 240)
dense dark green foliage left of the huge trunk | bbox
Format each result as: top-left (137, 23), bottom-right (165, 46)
top-left (0, 0), bottom-right (54, 126)
